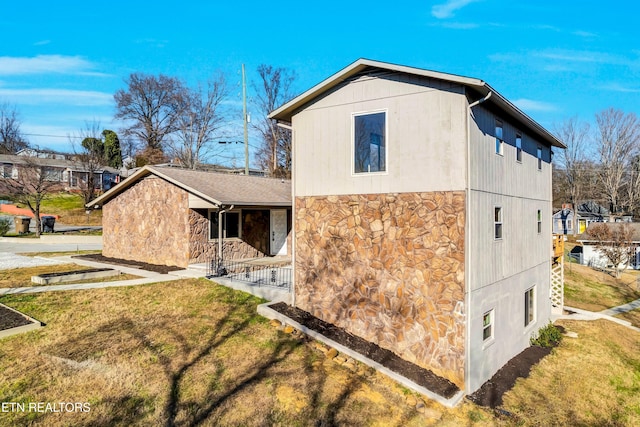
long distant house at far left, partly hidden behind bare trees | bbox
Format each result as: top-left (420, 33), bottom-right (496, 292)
top-left (0, 154), bottom-right (120, 191)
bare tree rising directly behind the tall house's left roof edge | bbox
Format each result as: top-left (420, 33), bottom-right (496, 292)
top-left (253, 64), bottom-right (295, 178)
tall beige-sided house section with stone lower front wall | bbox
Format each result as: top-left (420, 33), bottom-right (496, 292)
top-left (269, 59), bottom-right (564, 393)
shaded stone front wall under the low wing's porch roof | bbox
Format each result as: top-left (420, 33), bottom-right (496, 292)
top-left (189, 209), bottom-right (269, 263)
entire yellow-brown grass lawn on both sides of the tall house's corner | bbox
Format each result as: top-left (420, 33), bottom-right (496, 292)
top-left (0, 279), bottom-right (640, 426)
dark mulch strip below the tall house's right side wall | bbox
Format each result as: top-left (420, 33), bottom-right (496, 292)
top-left (467, 346), bottom-right (551, 408)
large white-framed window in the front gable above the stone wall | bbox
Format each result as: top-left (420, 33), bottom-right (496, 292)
top-left (353, 112), bottom-right (387, 173)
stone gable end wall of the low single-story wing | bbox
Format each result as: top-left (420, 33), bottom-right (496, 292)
top-left (102, 176), bottom-right (189, 267)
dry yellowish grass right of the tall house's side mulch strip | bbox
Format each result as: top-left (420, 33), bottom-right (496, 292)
top-left (504, 320), bottom-right (640, 426)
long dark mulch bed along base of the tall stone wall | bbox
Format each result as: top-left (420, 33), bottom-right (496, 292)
top-left (269, 302), bottom-right (460, 399)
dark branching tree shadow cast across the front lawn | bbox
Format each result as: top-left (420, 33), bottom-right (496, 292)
top-left (42, 298), bottom-right (376, 427)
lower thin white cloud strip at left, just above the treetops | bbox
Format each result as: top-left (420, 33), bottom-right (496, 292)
top-left (0, 88), bottom-right (113, 106)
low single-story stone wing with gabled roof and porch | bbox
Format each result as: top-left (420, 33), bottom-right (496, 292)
top-left (87, 166), bottom-right (291, 267)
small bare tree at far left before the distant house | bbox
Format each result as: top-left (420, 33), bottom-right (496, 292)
top-left (5, 156), bottom-right (61, 237)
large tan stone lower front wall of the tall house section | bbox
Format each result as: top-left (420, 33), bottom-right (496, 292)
top-left (294, 191), bottom-right (465, 388)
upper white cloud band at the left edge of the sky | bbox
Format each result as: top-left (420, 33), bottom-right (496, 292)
top-left (0, 55), bottom-right (104, 76)
